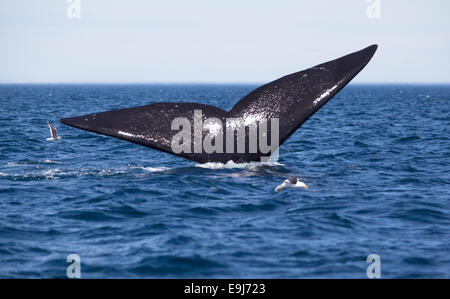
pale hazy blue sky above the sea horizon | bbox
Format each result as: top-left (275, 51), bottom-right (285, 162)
top-left (0, 0), bottom-right (450, 83)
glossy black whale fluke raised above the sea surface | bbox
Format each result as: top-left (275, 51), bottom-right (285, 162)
top-left (60, 45), bottom-right (377, 163)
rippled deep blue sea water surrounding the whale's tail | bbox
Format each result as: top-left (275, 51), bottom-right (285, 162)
top-left (0, 84), bottom-right (450, 278)
